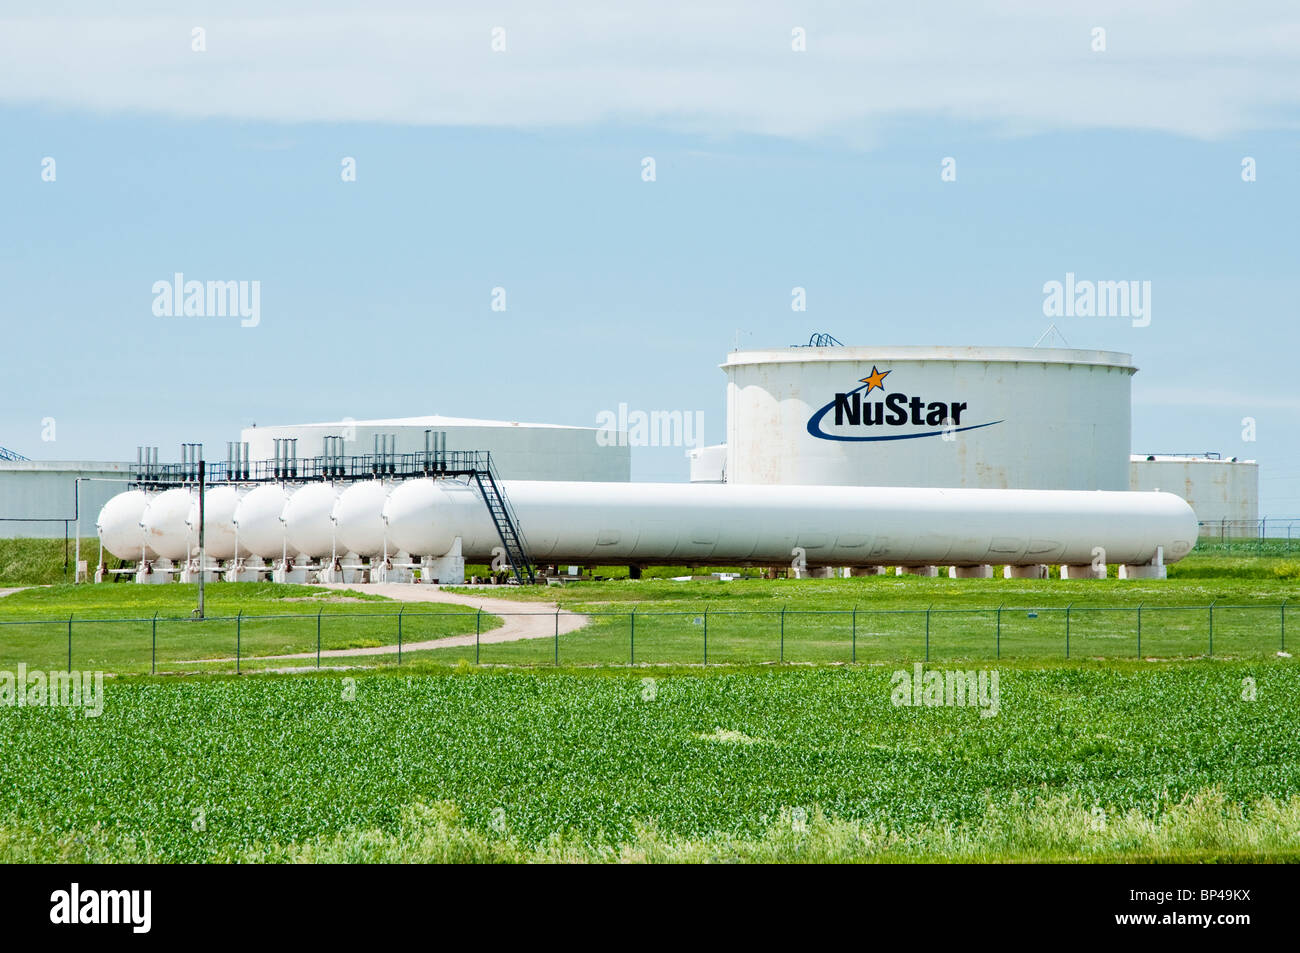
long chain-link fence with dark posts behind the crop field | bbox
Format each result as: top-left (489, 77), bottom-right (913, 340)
top-left (0, 601), bottom-right (1296, 675)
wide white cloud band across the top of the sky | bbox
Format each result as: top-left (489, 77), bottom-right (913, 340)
top-left (0, 0), bottom-right (1300, 142)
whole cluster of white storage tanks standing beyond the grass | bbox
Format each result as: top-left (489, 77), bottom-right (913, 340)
top-left (0, 342), bottom-right (1258, 582)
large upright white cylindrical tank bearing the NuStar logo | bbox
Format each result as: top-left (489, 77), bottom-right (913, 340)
top-left (722, 347), bottom-right (1136, 490)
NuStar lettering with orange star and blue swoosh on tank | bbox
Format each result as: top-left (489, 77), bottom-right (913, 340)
top-left (809, 364), bottom-right (1002, 441)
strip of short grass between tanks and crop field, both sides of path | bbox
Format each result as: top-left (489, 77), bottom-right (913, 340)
top-left (0, 555), bottom-right (1300, 673)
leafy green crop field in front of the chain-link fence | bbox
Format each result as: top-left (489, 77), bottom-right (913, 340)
top-left (0, 660), bottom-right (1300, 861)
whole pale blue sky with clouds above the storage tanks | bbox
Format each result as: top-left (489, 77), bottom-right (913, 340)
top-left (0, 4), bottom-right (1300, 516)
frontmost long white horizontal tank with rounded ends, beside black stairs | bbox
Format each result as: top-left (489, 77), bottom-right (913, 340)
top-left (385, 480), bottom-right (1196, 566)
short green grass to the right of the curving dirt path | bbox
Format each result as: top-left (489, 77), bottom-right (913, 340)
top-left (438, 576), bottom-right (1300, 664)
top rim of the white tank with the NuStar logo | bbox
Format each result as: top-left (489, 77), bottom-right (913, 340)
top-left (719, 345), bottom-right (1138, 372)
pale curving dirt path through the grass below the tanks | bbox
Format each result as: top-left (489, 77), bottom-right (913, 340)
top-left (181, 582), bottom-right (590, 664)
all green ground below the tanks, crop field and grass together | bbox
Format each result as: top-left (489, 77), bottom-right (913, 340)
top-left (0, 545), bottom-right (1300, 862)
